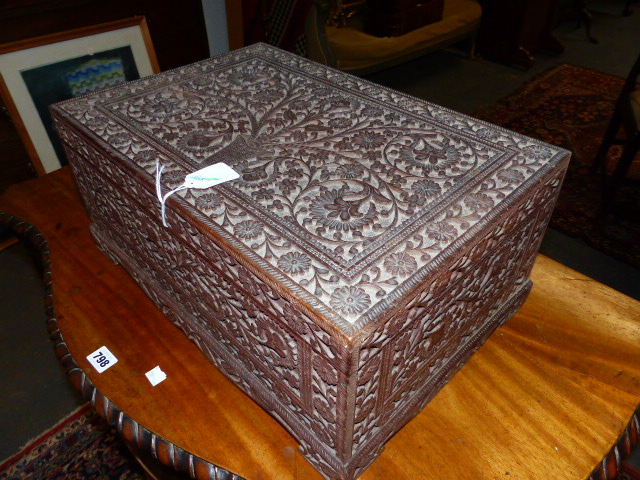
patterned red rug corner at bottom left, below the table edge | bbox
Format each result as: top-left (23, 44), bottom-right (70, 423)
top-left (0, 404), bottom-right (146, 480)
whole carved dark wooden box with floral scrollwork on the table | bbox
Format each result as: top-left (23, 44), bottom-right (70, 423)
top-left (52, 45), bottom-right (569, 479)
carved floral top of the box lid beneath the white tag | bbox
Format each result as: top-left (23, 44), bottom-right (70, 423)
top-left (55, 44), bottom-right (568, 334)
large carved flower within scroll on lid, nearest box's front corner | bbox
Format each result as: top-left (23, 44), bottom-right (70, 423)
top-left (311, 188), bottom-right (377, 231)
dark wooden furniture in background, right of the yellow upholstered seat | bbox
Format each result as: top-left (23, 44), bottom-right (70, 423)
top-left (477, 0), bottom-right (563, 69)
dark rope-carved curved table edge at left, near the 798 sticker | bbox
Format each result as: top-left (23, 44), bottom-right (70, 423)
top-left (0, 211), bottom-right (245, 480)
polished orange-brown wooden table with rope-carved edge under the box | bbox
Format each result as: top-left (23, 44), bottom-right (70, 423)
top-left (0, 167), bottom-right (640, 480)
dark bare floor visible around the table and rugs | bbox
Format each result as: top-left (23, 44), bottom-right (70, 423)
top-left (0, 0), bottom-right (640, 461)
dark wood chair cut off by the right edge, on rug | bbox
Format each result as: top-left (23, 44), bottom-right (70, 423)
top-left (592, 50), bottom-right (640, 211)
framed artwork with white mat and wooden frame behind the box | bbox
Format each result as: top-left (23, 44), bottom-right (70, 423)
top-left (0, 17), bottom-right (160, 175)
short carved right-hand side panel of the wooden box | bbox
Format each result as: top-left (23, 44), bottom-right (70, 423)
top-left (353, 163), bottom-right (564, 468)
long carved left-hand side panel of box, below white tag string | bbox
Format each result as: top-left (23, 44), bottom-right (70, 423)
top-left (55, 122), bottom-right (362, 477)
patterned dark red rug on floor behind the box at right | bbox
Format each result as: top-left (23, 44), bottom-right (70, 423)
top-left (475, 65), bottom-right (640, 268)
